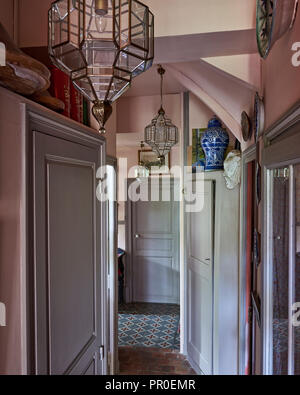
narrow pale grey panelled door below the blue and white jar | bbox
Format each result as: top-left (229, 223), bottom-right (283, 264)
top-left (187, 181), bottom-right (214, 375)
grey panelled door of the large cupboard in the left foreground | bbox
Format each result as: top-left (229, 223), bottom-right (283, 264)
top-left (33, 132), bottom-right (104, 375)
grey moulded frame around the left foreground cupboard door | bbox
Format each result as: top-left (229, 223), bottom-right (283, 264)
top-left (24, 103), bottom-right (107, 375)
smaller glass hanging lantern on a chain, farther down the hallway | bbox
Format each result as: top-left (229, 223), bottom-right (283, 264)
top-left (145, 66), bottom-right (178, 163)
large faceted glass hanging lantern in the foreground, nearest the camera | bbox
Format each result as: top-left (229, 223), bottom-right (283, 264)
top-left (49, 0), bottom-right (154, 132)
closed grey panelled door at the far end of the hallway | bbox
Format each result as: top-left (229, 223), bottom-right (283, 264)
top-left (131, 181), bottom-right (179, 304)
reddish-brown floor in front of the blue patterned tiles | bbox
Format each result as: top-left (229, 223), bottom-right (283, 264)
top-left (119, 346), bottom-right (196, 376)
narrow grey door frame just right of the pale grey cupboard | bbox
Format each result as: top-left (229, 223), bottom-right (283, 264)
top-left (239, 144), bottom-right (256, 375)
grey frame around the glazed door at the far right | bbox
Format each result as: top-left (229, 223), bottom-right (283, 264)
top-left (261, 102), bottom-right (300, 375)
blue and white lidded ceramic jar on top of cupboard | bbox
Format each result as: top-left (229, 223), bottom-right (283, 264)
top-left (201, 117), bottom-right (229, 171)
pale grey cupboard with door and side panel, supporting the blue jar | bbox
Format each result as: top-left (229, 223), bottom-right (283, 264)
top-left (186, 172), bottom-right (240, 375)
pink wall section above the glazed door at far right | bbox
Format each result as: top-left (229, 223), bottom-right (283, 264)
top-left (262, 9), bottom-right (300, 128)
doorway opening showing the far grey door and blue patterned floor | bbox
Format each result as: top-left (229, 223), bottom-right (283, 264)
top-left (118, 177), bottom-right (180, 362)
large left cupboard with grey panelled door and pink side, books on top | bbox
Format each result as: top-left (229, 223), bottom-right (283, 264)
top-left (0, 88), bottom-right (107, 375)
